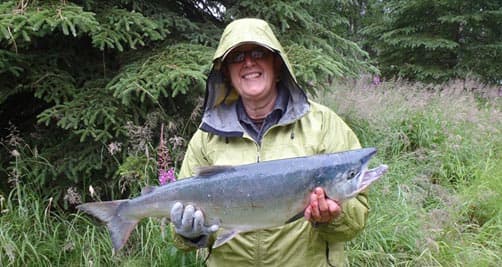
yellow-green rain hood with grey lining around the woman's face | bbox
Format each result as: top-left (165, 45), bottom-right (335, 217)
top-left (200, 18), bottom-right (309, 136)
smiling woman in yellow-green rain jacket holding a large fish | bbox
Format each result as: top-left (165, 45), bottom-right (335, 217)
top-left (171, 18), bottom-right (369, 267)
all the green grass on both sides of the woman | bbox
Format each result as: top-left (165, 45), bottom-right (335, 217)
top-left (0, 77), bottom-right (502, 266)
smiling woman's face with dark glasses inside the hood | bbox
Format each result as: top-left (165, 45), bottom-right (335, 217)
top-left (225, 44), bottom-right (281, 101)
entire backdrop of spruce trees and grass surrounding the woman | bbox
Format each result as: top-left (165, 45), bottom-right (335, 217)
top-left (0, 0), bottom-right (502, 266)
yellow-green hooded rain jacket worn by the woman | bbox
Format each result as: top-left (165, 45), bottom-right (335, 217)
top-left (174, 19), bottom-right (368, 267)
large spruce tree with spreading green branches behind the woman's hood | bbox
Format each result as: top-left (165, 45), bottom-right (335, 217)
top-left (0, 0), bottom-right (371, 203)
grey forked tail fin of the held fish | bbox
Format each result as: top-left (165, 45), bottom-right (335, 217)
top-left (77, 199), bottom-right (139, 255)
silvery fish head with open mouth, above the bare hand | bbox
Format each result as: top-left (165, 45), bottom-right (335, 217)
top-left (324, 148), bottom-right (387, 202)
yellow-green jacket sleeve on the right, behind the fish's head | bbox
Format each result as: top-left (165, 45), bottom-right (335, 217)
top-left (317, 108), bottom-right (369, 242)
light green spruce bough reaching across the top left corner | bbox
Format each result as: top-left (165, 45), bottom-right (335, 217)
top-left (0, 1), bottom-right (165, 51)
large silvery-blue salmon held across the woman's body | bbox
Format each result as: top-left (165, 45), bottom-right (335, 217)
top-left (77, 147), bottom-right (388, 252)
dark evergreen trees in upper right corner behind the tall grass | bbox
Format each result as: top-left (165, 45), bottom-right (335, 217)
top-left (361, 0), bottom-right (502, 84)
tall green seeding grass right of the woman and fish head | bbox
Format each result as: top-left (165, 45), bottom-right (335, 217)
top-left (320, 78), bottom-right (502, 266)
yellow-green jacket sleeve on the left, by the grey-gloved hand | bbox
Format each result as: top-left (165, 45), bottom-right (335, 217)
top-left (170, 130), bottom-right (214, 251)
